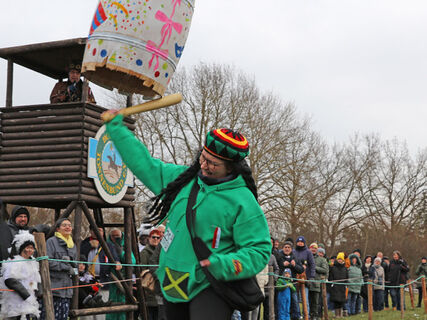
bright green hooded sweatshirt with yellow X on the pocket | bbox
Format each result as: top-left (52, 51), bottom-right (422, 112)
top-left (107, 115), bottom-right (271, 302)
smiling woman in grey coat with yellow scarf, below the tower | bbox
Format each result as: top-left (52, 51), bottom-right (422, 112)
top-left (42, 219), bottom-right (78, 320)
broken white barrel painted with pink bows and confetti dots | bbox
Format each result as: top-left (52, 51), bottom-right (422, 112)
top-left (82, 0), bottom-right (194, 96)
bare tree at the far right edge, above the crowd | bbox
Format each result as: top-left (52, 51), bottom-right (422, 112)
top-left (366, 140), bottom-right (427, 247)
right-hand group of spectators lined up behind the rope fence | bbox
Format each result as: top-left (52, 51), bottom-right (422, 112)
top-left (264, 236), bottom-right (427, 320)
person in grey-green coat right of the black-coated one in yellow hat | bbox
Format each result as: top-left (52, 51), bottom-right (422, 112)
top-left (348, 253), bottom-right (363, 315)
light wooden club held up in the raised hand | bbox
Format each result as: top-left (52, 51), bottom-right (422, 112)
top-left (101, 93), bottom-right (182, 122)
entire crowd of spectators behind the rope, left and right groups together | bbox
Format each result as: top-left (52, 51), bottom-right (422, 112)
top-left (0, 206), bottom-right (427, 320)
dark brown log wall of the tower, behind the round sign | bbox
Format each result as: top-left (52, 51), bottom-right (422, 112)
top-left (0, 103), bottom-right (135, 208)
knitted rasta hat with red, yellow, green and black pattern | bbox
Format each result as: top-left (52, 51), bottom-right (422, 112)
top-left (204, 129), bottom-right (249, 162)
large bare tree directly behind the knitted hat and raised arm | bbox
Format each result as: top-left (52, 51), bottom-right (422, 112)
top-left (108, 63), bottom-right (301, 222)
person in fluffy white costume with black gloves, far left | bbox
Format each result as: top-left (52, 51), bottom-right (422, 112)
top-left (0, 232), bottom-right (41, 320)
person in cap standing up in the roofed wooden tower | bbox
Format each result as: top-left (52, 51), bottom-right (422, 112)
top-left (50, 62), bottom-right (96, 103)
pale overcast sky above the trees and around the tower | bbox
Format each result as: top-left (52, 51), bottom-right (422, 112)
top-left (0, 0), bottom-right (427, 152)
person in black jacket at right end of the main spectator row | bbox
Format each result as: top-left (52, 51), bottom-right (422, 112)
top-left (389, 250), bottom-right (409, 310)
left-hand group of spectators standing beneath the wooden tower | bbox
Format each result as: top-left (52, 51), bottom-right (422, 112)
top-left (0, 206), bottom-right (165, 320)
